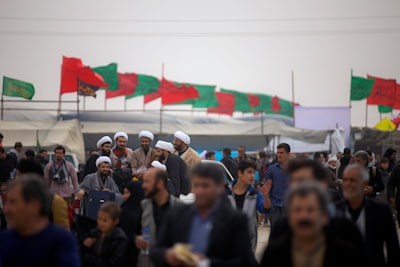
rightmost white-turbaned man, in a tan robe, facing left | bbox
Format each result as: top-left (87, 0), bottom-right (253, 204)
top-left (174, 131), bottom-right (201, 170)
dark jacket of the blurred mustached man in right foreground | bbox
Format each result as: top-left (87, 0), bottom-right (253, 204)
top-left (260, 223), bottom-right (366, 267)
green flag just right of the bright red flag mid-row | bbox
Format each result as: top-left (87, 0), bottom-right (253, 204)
top-left (176, 83), bottom-right (218, 108)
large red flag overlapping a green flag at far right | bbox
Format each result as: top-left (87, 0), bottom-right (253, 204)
top-left (367, 75), bottom-right (397, 107)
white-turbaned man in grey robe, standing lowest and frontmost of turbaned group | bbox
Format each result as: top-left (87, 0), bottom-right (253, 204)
top-left (76, 156), bottom-right (123, 203)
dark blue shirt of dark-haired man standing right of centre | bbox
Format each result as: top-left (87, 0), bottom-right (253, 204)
top-left (266, 163), bottom-right (289, 207)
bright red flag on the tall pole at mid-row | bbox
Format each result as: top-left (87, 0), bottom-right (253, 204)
top-left (159, 79), bottom-right (199, 105)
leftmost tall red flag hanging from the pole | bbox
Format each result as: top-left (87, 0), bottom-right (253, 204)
top-left (60, 56), bottom-right (83, 95)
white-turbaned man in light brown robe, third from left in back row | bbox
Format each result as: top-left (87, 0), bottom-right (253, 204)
top-left (131, 131), bottom-right (157, 179)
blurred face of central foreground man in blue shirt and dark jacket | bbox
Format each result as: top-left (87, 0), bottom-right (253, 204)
top-left (191, 176), bottom-right (224, 209)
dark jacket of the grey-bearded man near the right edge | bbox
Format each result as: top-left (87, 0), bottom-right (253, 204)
top-left (337, 198), bottom-right (400, 266)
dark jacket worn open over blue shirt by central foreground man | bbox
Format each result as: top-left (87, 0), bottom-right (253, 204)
top-left (150, 204), bottom-right (257, 267)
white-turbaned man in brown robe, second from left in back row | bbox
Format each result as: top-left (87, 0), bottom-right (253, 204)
top-left (110, 132), bottom-right (133, 169)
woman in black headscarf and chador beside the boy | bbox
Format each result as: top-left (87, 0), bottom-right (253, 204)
top-left (119, 182), bottom-right (144, 266)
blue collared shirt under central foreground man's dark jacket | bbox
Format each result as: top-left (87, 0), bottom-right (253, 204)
top-left (189, 204), bottom-right (219, 255)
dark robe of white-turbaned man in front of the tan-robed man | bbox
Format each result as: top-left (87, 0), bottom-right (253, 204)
top-left (165, 154), bottom-right (188, 196)
